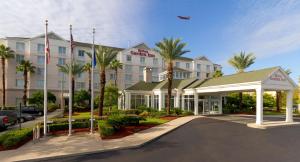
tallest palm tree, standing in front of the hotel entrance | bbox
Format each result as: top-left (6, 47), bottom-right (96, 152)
top-left (155, 38), bottom-right (189, 115)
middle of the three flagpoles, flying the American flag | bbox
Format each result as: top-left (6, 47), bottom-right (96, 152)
top-left (68, 25), bottom-right (73, 136)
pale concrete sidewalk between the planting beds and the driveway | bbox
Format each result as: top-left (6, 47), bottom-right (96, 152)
top-left (0, 116), bottom-right (201, 161)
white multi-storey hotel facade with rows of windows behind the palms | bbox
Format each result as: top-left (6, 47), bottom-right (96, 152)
top-left (0, 32), bottom-right (221, 106)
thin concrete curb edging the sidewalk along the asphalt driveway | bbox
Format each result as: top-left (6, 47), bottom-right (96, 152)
top-left (20, 118), bottom-right (197, 162)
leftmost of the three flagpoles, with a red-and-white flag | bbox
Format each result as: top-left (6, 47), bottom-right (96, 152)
top-left (44, 20), bottom-right (49, 137)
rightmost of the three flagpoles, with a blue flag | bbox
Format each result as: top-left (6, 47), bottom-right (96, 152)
top-left (91, 28), bottom-right (95, 134)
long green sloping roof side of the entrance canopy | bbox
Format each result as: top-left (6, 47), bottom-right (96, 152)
top-left (195, 67), bottom-right (279, 88)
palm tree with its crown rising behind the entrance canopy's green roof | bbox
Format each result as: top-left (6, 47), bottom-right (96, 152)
top-left (228, 51), bottom-right (256, 109)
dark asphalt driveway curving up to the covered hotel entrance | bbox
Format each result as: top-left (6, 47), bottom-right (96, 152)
top-left (41, 118), bottom-right (300, 162)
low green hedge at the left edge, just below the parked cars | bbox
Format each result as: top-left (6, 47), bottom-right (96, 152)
top-left (0, 128), bottom-right (32, 148)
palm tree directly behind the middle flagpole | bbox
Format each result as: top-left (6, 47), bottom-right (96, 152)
top-left (57, 62), bottom-right (84, 107)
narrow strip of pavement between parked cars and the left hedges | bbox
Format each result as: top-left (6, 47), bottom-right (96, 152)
top-left (0, 109), bottom-right (62, 134)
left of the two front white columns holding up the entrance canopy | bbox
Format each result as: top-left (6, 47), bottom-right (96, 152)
top-left (256, 87), bottom-right (264, 125)
